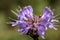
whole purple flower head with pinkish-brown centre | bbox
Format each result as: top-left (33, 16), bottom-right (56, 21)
top-left (12, 6), bottom-right (58, 39)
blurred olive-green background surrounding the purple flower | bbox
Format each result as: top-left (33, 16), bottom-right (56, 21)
top-left (0, 0), bottom-right (60, 40)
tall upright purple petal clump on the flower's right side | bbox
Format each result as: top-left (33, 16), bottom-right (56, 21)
top-left (41, 7), bottom-right (53, 29)
